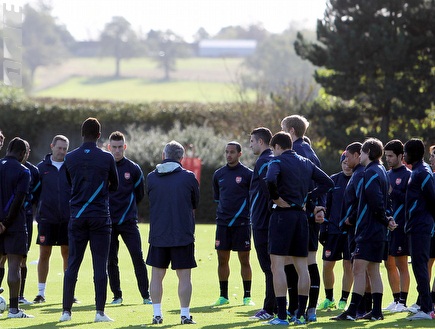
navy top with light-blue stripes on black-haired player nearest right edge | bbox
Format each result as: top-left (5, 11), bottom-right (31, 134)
top-left (405, 160), bottom-right (435, 234)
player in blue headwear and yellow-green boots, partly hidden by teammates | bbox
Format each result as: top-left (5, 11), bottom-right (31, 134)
top-left (317, 151), bottom-right (353, 310)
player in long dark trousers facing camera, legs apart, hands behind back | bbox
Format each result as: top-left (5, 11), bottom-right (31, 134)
top-left (107, 131), bottom-right (151, 304)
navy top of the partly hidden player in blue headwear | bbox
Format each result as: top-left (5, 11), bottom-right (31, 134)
top-left (322, 171), bottom-right (351, 234)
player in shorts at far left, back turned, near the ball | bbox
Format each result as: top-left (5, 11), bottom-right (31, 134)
top-left (0, 137), bottom-right (33, 318)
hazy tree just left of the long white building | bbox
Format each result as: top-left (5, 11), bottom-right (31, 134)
top-left (147, 30), bottom-right (191, 81)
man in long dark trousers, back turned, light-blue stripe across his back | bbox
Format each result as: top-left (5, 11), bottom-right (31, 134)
top-left (60, 118), bottom-right (118, 322)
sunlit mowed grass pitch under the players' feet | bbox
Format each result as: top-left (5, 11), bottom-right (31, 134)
top-left (0, 224), bottom-right (435, 329)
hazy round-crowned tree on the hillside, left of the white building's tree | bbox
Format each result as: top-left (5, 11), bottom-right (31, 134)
top-left (100, 16), bottom-right (141, 78)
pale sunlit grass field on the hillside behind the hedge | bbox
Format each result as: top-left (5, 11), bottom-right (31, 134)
top-left (32, 58), bottom-right (255, 102)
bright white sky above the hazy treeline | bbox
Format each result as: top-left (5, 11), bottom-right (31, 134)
top-left (11, 0), bottom-right (326, 41)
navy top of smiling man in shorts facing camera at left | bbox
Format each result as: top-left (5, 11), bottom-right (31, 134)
top-left (35, 154), bottom-right (71, 224)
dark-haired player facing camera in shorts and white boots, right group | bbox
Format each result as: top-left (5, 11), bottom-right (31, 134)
top-left (384, 139), bottom-right (411, 312)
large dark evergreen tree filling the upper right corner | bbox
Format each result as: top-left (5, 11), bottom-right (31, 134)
top-left (294, 0), bottom-right (435, 141)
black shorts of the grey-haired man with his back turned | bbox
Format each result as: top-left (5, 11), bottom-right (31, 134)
top-left (146, 243), bottom-right (196, 270)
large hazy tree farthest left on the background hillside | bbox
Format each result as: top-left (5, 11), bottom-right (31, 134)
top-left (22, 2), bottom-right (70, 88)
